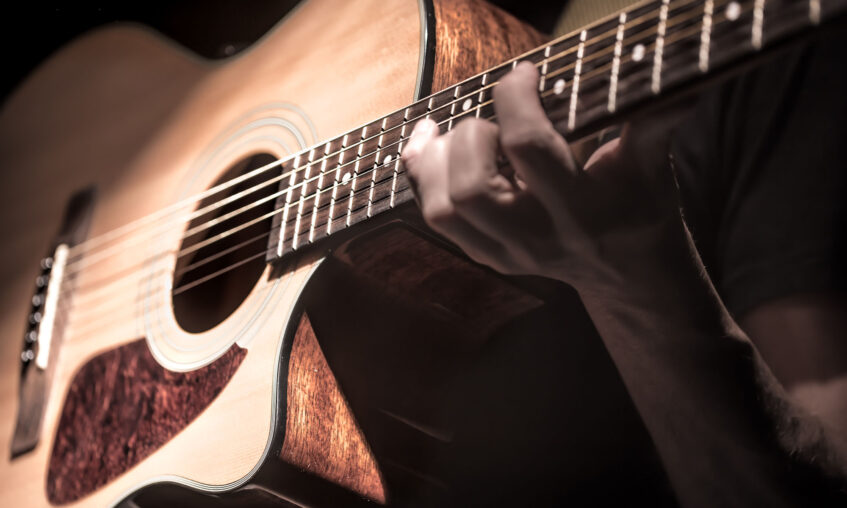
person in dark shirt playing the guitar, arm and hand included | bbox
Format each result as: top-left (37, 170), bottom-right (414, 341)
top-left (403, 11), bottom-right (847, 506)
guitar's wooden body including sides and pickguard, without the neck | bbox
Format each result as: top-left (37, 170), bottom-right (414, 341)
top-left (0, 0), bottom-right (588, 507)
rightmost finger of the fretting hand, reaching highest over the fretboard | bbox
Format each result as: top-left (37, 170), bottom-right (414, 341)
top-left (494, 62), bottom-right (579, 211)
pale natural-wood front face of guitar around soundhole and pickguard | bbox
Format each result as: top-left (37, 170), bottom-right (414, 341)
top-left (0, 0), bottom-right (421, 507)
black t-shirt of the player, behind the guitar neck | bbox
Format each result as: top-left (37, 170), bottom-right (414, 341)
top-left (672, 28), bottom-right (847, 316)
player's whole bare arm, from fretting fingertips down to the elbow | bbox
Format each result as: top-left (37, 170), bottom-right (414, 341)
top-left (403, 64), bottom-right (845, 506)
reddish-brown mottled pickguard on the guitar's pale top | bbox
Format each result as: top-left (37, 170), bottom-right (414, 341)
top-left (46, 338), bottom-right (247, 504)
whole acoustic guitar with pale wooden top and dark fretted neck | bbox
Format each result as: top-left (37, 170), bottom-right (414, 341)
top-left (0, 0), bottom-right (847, 507)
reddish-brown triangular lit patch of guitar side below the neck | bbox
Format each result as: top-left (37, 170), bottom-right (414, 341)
top-left (280, 313), bottom-right (386, 504)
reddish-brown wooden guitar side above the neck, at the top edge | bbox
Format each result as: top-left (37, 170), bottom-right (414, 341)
top-left (432, 0), bottom-right (548, 92)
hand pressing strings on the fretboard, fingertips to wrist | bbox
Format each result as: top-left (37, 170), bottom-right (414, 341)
top-left (402, 63), bottom-right (690, 292)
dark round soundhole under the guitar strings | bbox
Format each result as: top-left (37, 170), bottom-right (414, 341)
top-left (172, 153), bottom-right (279, 333)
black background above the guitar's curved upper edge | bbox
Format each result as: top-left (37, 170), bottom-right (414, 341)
top-left (0, 0), bottom-right (565, 104)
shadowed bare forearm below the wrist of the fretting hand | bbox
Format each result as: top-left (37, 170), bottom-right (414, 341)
top-left (580, 226), bottom-right (847, 506)
